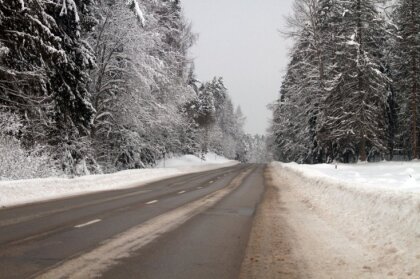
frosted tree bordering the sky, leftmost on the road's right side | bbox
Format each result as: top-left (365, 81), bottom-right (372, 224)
top-left (272, 0), bottom-right (333, 163)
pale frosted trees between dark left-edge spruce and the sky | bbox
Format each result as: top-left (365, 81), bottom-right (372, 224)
top-left (85, 1), bottom-right (200, 171)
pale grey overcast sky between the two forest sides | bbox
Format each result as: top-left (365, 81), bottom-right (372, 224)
top-left (182, 0), bottom-right (293, 134)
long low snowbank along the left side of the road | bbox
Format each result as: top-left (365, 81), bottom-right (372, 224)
top-left (0, 153), bottom-right (238, 210)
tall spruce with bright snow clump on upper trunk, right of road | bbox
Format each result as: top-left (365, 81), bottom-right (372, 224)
top-left (319, 0), bottom-right (389, 162)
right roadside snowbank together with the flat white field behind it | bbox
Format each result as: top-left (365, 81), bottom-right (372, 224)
top-left (272, 162), bottom-right (420, 278)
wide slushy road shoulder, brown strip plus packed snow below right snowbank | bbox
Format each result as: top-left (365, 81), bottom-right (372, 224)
top-left (240, 166), bottom-right (398, 279)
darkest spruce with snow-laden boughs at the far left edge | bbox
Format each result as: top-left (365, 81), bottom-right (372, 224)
top-left (0, 0), bottom-right (94, 173)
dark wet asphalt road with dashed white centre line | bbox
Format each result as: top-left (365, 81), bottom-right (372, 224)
top-left (0, 165), bottom-right (265, 279)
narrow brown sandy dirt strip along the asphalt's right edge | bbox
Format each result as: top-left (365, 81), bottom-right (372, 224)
top-left (240, 165), bottom-right (301, 279)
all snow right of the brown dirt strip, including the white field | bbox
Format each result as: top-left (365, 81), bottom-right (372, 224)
top-left (271, 162), bottom-right (420, 278)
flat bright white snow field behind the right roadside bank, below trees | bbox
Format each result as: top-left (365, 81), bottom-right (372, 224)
top-left (283, 161), bottom-right (420, 192)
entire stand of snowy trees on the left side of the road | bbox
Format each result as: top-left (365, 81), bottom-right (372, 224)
top-left (0, 0), bottom-right (249, 179)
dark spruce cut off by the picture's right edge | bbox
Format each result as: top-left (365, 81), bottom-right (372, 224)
top-left (392, 0), bottom-right (420, 159)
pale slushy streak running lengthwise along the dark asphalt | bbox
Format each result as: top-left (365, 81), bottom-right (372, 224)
top-left (37, 169), bottom-right (252, 279)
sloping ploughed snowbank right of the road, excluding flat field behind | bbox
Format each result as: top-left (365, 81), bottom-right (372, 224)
top-left (271, 163), bottom-right (420, 278)
